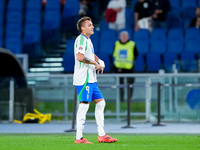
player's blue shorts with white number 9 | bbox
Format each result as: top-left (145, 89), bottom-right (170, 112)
top-left (76, 82), bottom-right (103, 102)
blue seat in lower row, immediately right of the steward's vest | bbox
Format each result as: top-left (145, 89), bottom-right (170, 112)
top-left (134, 54), bottom-right (145, 72)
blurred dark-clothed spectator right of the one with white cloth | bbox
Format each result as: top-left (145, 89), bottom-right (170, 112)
top-left (149, 0), bottom-right (171, 28)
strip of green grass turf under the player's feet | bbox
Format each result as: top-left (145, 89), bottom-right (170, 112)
top-left (0, 133), bottom-right (200, 150)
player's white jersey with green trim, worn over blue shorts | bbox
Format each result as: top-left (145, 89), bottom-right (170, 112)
top-left (73, 34), bottom-right (97, 85)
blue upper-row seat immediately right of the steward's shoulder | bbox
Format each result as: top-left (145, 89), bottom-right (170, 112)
top-left (135, 40), bottom-right (149, 54)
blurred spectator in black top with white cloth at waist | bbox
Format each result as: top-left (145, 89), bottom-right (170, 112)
top-left (134, 0), bottom-right (152, 31)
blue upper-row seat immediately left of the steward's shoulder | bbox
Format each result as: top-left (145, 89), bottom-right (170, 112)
top-left (99, 40), bottom-right (115, 55)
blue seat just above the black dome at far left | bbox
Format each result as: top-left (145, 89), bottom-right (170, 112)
top-left (5, 38), bottom-right (22, 54)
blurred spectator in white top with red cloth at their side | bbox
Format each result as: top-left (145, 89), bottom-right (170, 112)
top-left (107, 0), bottom-right (126, 31)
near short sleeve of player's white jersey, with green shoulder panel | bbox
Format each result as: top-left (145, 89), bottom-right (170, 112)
top-left (75, 35), bottom-right (87, 55)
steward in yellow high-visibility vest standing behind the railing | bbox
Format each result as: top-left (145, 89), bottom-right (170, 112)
top-left (113, 31), bottom-right (138, 101)
